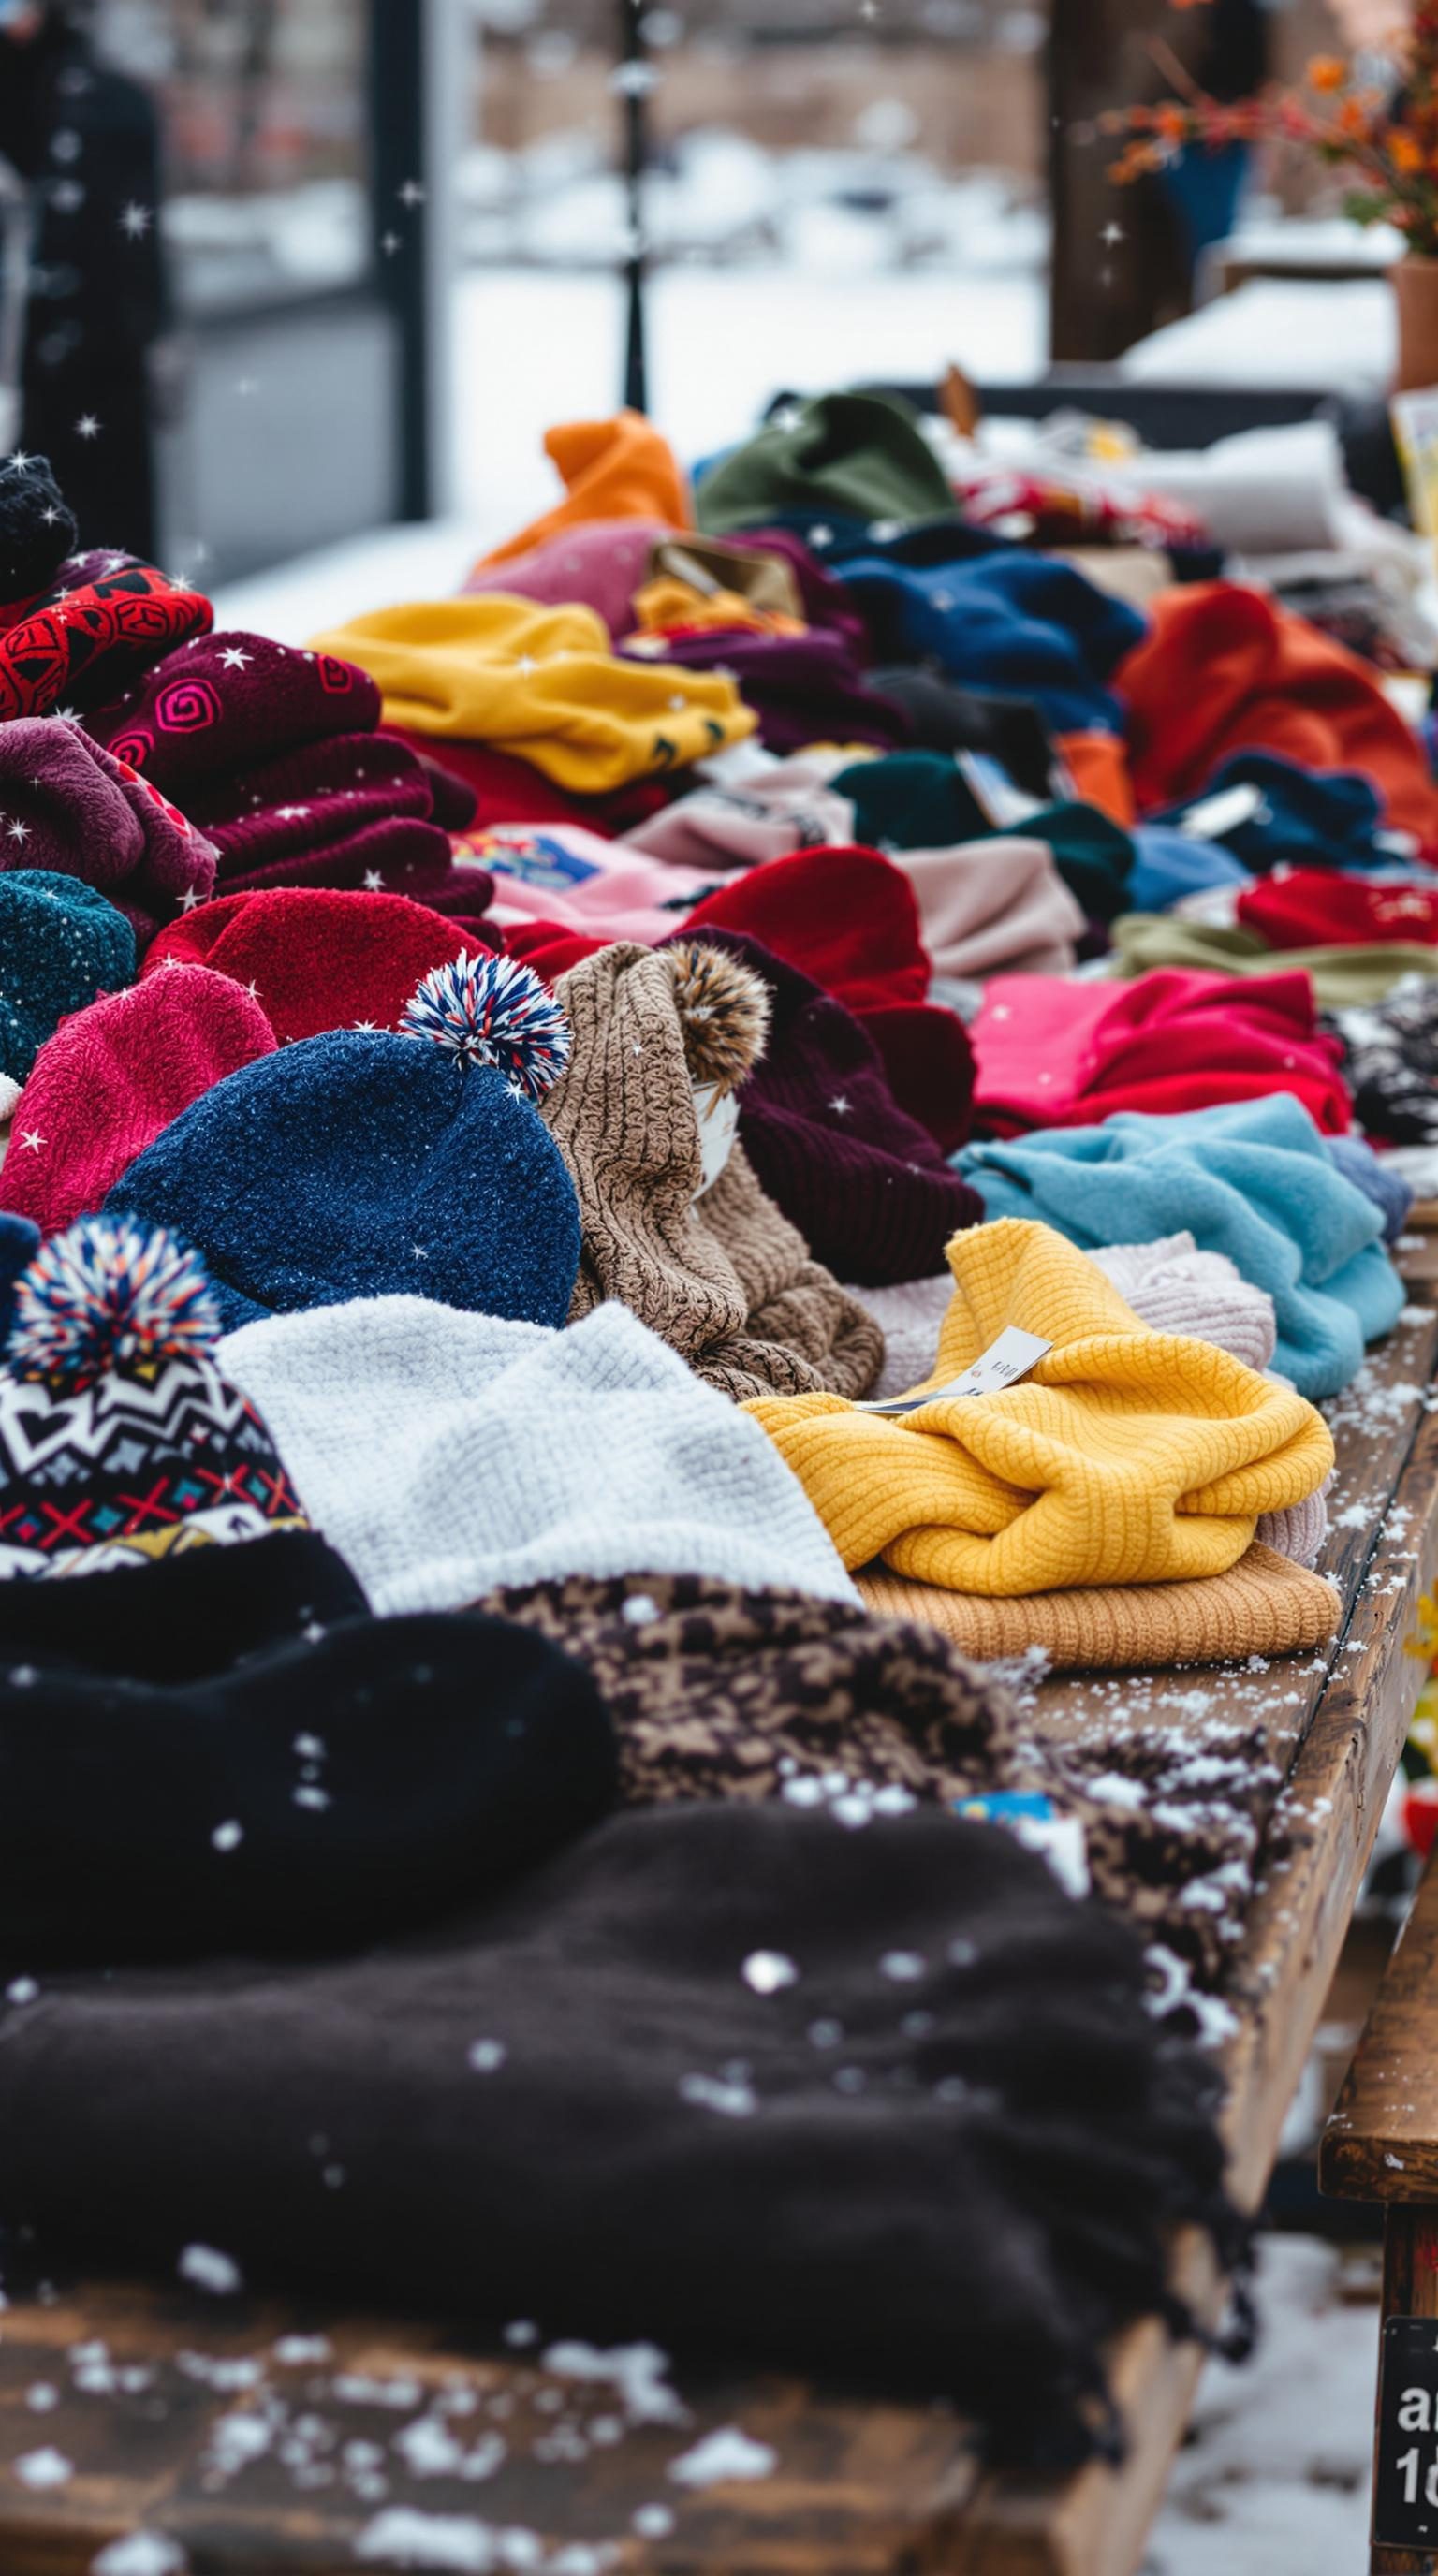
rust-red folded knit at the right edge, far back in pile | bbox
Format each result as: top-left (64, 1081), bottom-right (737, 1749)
top-left (1113, 582), bottom-right (1438, 860)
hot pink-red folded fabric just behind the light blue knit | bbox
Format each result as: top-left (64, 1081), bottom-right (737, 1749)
top-left (969, 966), bottom-right (1350, 1134)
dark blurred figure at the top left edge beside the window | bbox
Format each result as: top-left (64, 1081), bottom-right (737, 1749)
top-left (0, 0), bottom-right (168, 559)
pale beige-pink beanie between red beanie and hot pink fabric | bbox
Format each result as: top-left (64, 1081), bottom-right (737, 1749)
top-left (894, 835), bottom-right (1085, 979)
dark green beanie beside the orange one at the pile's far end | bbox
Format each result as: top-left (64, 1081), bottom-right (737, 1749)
top-left (693, 394), bottom-right (953, 535)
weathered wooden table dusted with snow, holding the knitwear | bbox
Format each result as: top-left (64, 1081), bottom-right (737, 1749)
top-left (11, 1239), bottom-right (1438, 2576)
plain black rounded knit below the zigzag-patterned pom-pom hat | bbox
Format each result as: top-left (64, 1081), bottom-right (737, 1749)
top-left (0, 1532), bottom-right (619, 1973)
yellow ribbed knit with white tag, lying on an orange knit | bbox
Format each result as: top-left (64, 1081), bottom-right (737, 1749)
top-left (745, 1219), bottom-right (1332, 1597)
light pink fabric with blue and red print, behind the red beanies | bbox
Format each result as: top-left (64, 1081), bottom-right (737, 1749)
top-left (463, 822), bottom-right (713, 948)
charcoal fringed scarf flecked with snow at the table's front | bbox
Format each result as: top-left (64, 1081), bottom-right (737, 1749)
top-left (0, 1803), bottom-right (1226, 2457)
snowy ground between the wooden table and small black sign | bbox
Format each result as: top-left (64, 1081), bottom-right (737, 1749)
top-left (1141, 2236), bottom-right (1379, 2576)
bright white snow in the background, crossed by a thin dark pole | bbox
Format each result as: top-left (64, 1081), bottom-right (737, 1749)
top-left (216, 268), bottom-right (1047, 644)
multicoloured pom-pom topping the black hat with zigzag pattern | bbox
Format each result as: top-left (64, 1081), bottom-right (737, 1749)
top-left (6, 1216), bottom-right (219, 1394)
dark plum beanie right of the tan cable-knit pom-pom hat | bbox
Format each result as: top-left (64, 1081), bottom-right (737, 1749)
top-left (681, 929), bottom-right (982, 1282)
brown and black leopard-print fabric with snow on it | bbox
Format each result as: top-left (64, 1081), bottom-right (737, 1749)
top-left (477, 1573), bottom-right (1281, 2027)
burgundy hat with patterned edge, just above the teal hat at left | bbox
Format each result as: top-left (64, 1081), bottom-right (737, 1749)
top-left (0, 716), bottom-right (213, 929)
